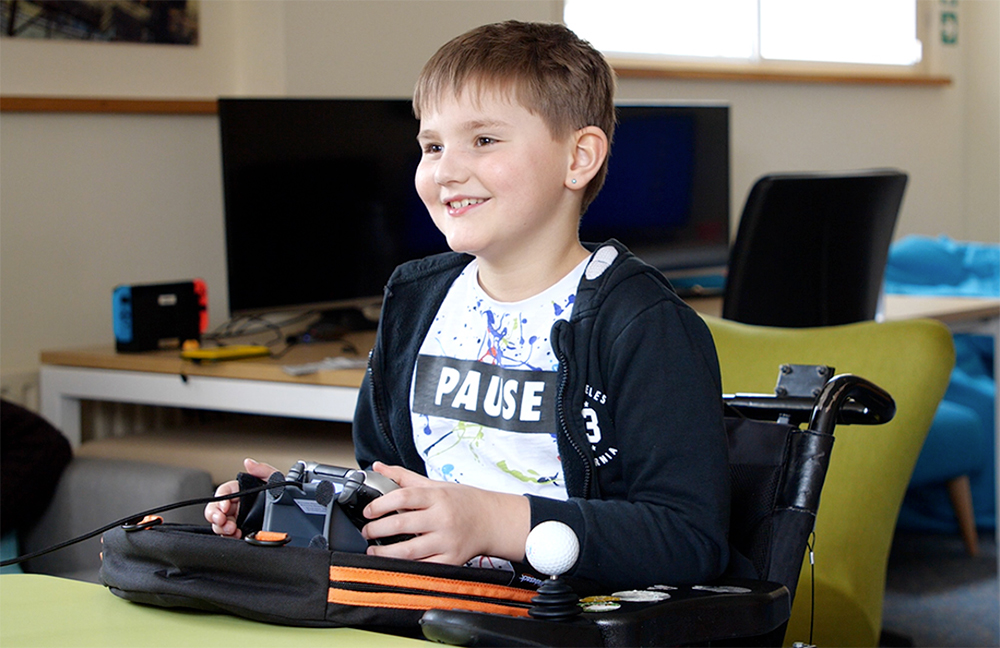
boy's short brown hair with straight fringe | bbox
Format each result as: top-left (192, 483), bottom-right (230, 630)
top-left (413, 20), bottom-right (615, 213)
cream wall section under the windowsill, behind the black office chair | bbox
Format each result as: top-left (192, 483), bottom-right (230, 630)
top-left (620, 80), bottom-right (964, 239)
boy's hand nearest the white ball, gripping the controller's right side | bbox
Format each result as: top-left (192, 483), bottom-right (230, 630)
top-left (362, 462), bottom-right (531, 565)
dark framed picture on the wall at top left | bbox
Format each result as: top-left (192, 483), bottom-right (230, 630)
top-left (0, 0), bottom-right (200, 45)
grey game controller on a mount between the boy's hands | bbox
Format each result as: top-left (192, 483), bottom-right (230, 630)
top-left (263, 461), bottom-right (412, 553)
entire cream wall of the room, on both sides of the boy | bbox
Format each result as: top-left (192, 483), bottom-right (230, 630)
top-left (0, 0), bottom-right (1000, 374)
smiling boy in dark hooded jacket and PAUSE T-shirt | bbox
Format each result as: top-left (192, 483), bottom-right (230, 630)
top-left (206, 22), bottom-right (729, 588)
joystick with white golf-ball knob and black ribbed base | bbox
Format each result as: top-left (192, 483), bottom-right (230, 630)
top-left (524, 520), bottom-right (580, 621)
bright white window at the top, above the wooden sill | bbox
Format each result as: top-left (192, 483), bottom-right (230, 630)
top-left (563, 0), bottom-right (921, 66)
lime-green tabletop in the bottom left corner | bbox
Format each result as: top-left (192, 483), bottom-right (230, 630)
top-left (0, 574), bottom-right (428, 648)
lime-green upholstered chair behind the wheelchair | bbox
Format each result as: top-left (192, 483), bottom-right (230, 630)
top-left (704, 316), bottom-right (955, 646)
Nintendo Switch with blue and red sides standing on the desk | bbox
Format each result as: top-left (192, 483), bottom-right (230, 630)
top-left (111, 279), bottom-right (208, 352)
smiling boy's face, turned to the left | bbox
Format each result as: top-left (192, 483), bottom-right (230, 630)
top-left (416, 91), bottom-right (580, 264)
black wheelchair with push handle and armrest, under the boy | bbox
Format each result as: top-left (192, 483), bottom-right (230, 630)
top-left (420, 365), bottom-right (895, 646)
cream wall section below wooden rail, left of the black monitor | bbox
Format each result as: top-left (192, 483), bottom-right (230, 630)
top-left (0, 113), bottom-right (225, 373)
